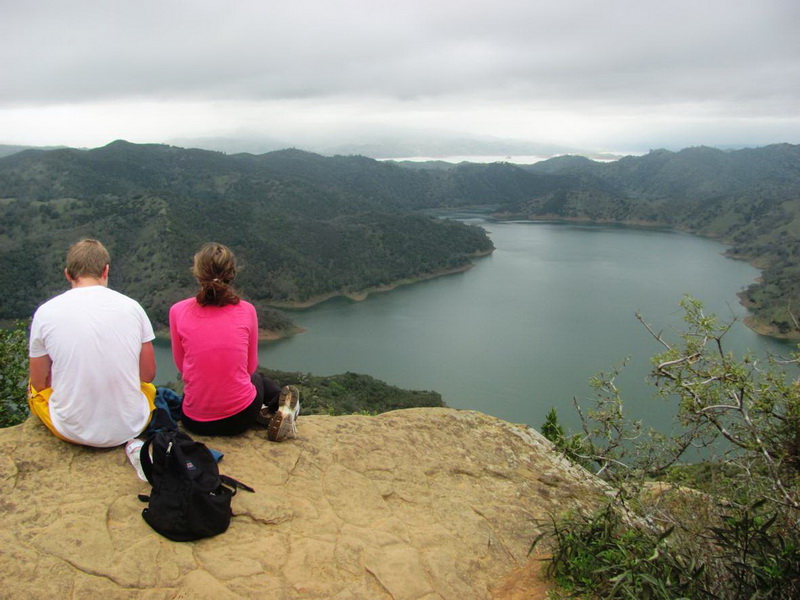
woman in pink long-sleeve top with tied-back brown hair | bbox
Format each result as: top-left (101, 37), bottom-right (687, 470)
top-left (169, 243), bottom-right (300, 441)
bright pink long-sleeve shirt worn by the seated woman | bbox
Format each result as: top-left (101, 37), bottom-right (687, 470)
top-left (169, 298), bottom-right (258, 421)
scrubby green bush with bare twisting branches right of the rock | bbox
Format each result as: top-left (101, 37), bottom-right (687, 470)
top-left (532, 298), bottom-right (800, 600)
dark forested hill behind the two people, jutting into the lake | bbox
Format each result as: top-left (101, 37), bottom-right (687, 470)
top-left (0, 141), bottom-right (492, 328)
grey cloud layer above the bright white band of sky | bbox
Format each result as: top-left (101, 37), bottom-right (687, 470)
top-left (0, 0), bottom-right (800, 150)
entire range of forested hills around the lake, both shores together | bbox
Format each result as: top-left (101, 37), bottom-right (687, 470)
top-left (0, 141), bottom-right (800, 334)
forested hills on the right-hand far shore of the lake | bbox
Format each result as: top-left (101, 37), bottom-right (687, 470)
top-left (520, 144), bottom-right (800, 337)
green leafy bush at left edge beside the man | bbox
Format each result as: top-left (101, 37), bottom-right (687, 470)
top-left (0, 321), bottom-right (29, 427)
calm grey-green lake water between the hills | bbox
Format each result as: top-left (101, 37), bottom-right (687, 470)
top-left (152, 219), bottom-right (795, 427)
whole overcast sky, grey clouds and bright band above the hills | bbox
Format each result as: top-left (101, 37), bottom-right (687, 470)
top-left (0, 0), bottom-right (800, 152)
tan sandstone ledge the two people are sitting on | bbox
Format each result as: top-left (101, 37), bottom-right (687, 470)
top-left (0, 408), bottom-right (602, 600)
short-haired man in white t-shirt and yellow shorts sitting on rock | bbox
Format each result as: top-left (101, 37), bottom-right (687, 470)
top-left (28, 239), bottom-right (156, 448)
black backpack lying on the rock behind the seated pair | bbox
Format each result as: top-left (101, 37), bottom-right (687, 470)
top-left (139, 431), bottom-right (254, 542)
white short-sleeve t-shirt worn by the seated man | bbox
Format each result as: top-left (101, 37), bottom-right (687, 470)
top-left (30, 285), bottom-right (155, 448)
